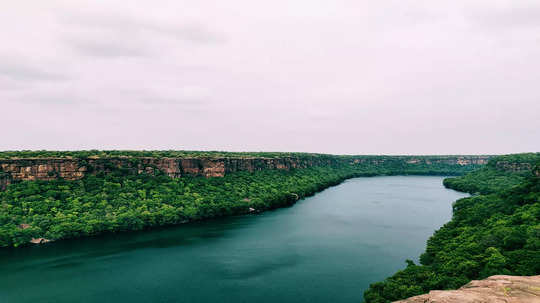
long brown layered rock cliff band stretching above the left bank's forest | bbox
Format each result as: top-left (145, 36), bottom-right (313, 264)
top-left (0, 156), bottom-right (489, 189)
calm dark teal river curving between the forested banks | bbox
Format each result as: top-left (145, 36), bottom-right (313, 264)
top-left (0, 176), bottom-right (465, 303)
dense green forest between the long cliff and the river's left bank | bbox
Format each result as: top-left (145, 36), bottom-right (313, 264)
top-left (0, 151), bottom-right (477, 247)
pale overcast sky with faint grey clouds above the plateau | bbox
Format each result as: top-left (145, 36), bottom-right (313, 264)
top-left (0, 0), bottom-right (540, 154)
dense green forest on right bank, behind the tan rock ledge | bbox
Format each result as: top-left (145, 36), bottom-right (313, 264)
top-left (364, 153), bottom-right (540, 303)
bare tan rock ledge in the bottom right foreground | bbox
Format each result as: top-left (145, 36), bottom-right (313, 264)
top-left (396, 275), bottom-right (540, 303)
